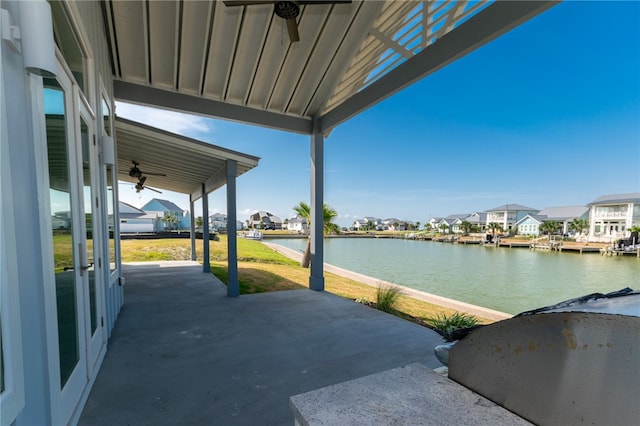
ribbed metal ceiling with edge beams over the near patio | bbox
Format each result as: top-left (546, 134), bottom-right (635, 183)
top-left (102, 0), bottom-right (557, 134)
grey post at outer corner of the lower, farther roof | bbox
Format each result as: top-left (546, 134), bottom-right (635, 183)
top-left (227, 160), bottom-right (240, 297)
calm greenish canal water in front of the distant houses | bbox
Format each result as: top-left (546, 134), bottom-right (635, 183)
top-left (270, 238), bottom-right (640, 314)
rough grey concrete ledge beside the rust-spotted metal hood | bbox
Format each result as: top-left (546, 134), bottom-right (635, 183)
top-left (290, 363), bottom-right (530, 426)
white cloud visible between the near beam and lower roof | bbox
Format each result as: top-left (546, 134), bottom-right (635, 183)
top-left (116, 102), bottom-right (213, 137)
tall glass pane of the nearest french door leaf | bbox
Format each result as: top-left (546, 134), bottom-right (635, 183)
top-left (44, 78), bottom-right (80, 388)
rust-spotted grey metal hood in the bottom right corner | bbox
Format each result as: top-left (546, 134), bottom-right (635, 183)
top-left (449, 292), bottom-right (640, 425)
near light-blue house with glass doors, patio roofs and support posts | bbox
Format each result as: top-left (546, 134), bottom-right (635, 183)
top-left (0, 0), bottom-right (555, 426)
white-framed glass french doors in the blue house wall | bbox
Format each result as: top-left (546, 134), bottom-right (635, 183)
top-left (43, 55), bottom-right (104, 422)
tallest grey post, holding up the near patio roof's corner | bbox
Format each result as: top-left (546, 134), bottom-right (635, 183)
top-left (309, 120), bottom-right (324, 291)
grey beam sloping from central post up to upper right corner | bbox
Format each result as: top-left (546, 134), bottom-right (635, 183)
top-left (320, 1), bottom-right (560, 133)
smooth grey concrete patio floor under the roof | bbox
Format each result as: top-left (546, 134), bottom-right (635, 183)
top-left (79, 262), bottom-right (442, 426)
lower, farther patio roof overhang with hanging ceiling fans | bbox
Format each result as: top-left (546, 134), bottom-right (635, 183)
top-left (115, 117), bottom-right (260, 200)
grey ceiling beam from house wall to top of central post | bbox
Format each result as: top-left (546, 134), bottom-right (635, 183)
top-left (113, 80), bottom-right (312, 135)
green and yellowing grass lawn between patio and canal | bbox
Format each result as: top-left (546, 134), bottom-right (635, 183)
top-left (121, 235), bottom-right (484, 322)
